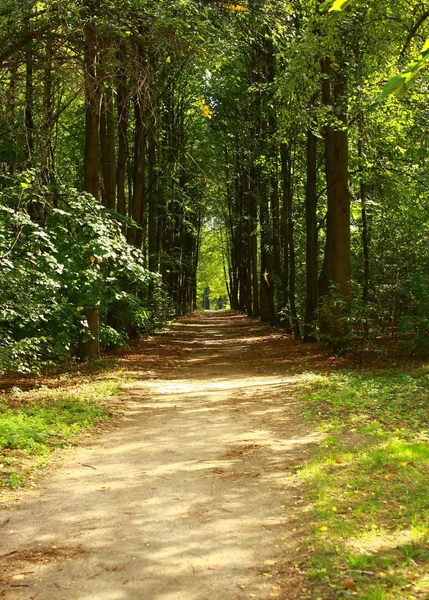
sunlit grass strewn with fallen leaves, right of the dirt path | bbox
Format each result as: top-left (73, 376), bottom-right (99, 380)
top-left (299, 366), bottom-right (429, 600)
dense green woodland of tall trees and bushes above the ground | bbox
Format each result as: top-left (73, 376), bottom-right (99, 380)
top-left (0, 0), bottom-right (429, 372)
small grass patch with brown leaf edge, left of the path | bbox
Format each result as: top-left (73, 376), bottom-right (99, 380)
top-left (0, 365), bottom-right (123, 491)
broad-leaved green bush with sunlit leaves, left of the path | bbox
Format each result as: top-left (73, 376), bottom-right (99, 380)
top-left (0, 171), bottom-right (171, 372)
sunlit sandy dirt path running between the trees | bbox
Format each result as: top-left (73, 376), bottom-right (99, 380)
top-left (0, 313), bottom-right (317, 600)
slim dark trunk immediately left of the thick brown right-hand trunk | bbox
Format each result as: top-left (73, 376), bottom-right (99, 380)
top-left (304, 129), bottom-right (319, 342)
